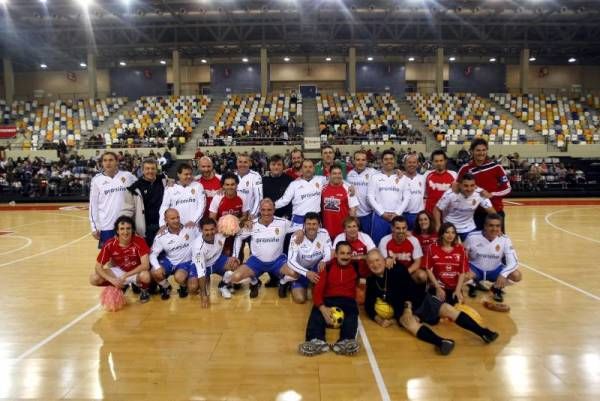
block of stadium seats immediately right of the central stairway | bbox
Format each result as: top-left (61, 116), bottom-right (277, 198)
top-left (317, 93), bottom-right (423, 145)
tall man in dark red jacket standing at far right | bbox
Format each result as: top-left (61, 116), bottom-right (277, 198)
top-left (458, 138), bottom-right (511, 232)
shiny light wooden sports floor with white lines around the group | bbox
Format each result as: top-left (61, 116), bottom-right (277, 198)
top-left (0, 199), bottom-right (600, 401)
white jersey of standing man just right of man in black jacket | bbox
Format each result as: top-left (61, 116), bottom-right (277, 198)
top-left (159, 181), bottom-right (206, 226)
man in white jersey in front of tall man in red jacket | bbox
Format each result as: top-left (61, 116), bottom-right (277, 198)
top-left (433, 173), bottom-right (496, 241)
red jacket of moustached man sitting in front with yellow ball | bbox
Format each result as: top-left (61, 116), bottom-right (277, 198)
top-left (313, 259), bottom-right (358, 307)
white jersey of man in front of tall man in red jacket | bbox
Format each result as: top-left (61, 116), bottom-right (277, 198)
top-left (436, 189), bottom-right (492, 234)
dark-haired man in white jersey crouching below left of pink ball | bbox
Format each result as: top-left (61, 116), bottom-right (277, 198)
top-left (192, 217), bottom-right (240, 307)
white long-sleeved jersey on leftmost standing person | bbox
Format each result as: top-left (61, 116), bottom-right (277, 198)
top-left (89, 171), bottom-right (137, 231)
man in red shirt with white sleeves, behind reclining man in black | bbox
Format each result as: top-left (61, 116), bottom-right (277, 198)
top-left (379, 216), bottom-right (427, 283)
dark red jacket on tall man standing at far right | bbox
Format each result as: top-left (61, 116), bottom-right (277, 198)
top-left (458, 160), bottom-right (511, 212)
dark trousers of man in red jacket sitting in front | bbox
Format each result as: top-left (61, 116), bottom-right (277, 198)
top-left (306, 297), bottom-right (358, 341)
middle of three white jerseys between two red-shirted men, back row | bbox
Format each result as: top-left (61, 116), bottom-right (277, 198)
top-left (368, 173), bottom-right (410, 216)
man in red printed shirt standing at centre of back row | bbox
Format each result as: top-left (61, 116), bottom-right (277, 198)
top-left (321, 165), bottom-right (358, 240)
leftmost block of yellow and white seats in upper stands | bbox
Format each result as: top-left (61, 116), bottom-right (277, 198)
top-left (0, 98), bottom-right (127, 149)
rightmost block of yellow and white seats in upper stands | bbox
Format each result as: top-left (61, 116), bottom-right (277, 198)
top-left (490, 93), bottom-right (600, 148)
